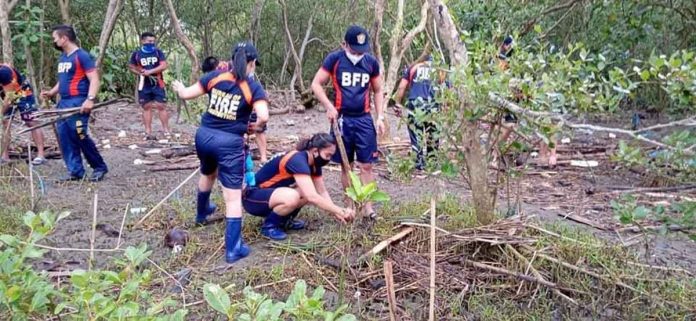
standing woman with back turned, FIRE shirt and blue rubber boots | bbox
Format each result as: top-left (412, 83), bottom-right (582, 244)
top-left (173, 42), bottom-right (268, 263)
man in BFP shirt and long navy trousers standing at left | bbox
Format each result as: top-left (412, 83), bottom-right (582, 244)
top-left (41, 25), bottom-right (108, 182)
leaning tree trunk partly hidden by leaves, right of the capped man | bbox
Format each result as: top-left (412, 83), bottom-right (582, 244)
top-left (428, 0), bottom-right (497, 225)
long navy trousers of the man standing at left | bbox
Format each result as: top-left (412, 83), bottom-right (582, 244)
top-left (56, 98), bottom-right (108, 177)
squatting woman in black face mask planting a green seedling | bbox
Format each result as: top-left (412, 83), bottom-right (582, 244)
top-left (242, 133), bottom-right (355, 240)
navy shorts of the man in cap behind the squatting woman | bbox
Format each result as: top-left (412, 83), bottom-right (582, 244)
top-left (331, 114), bottom-right (379, 164)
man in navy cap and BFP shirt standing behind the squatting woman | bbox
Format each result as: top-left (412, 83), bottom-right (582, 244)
top-left (312, 25), bottom-right (385, 217)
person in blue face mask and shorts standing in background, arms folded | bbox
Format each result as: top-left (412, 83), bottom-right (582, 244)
top-left (128, 32), bottom-right (171, 140)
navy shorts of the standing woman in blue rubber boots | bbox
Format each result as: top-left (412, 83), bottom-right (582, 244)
top-left (196, 127), bottom-right (244, 189)
